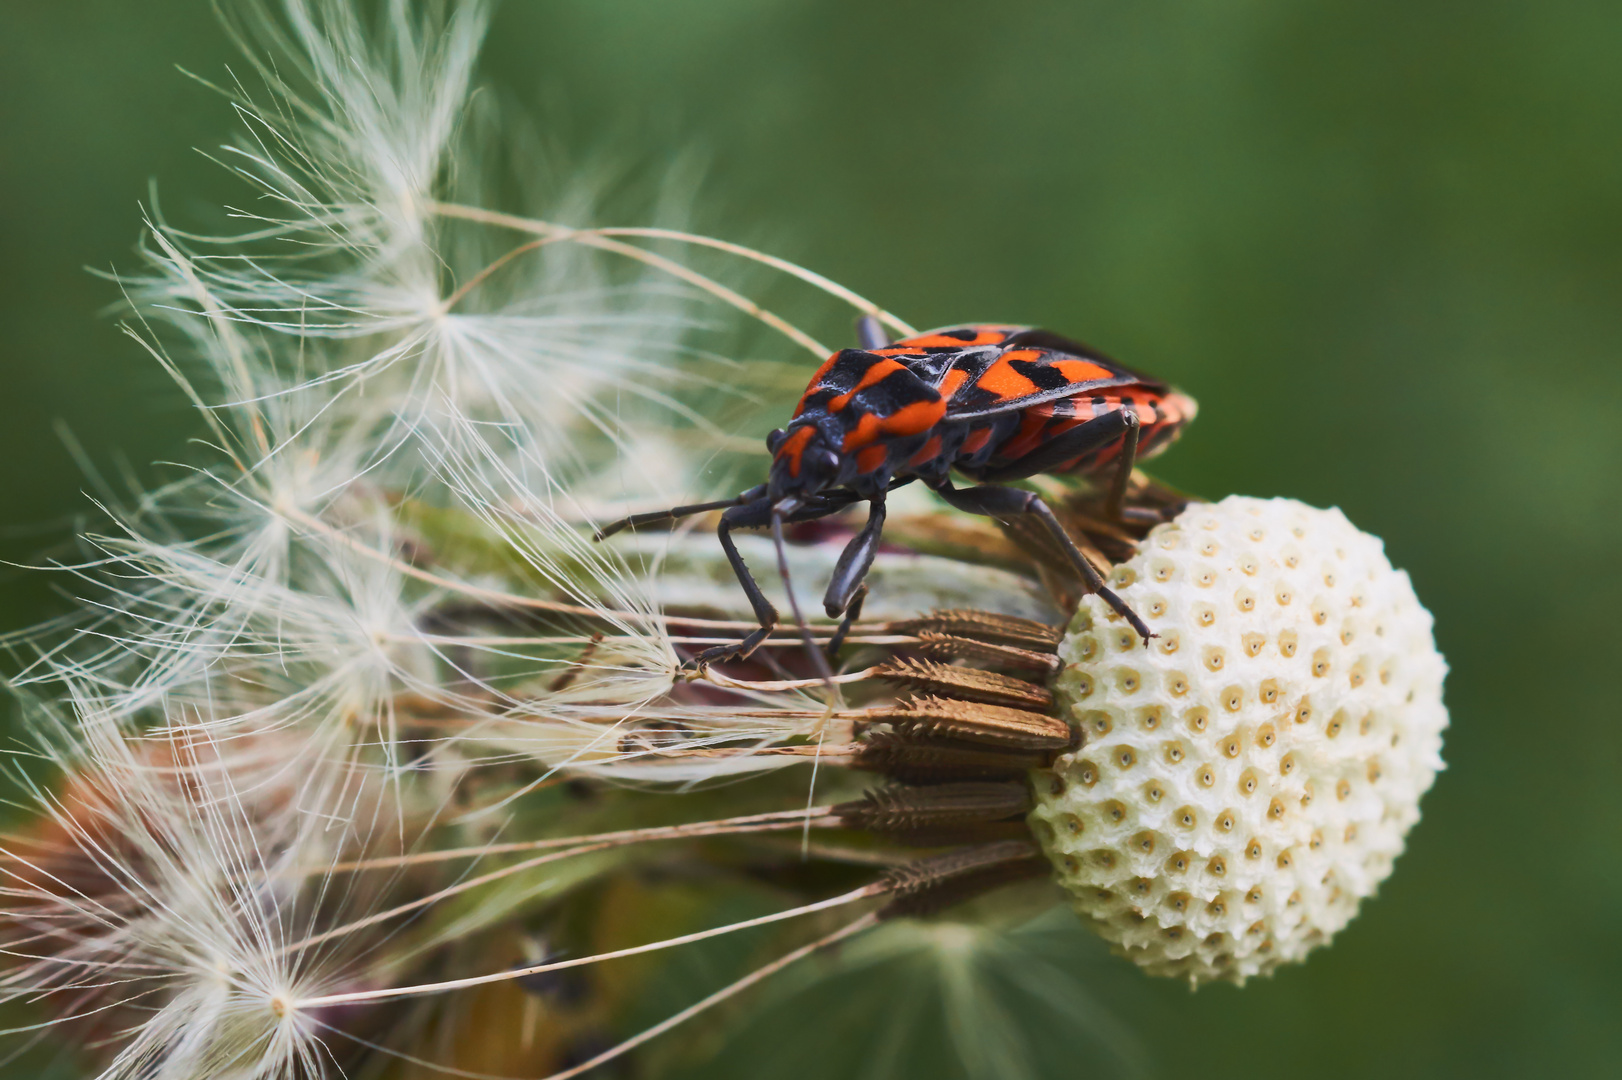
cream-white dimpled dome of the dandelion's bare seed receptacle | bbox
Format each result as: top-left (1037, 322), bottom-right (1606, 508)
top-left (1030, 496), bottom-right (1447, 986)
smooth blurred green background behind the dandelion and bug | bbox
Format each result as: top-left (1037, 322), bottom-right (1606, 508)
top-left (0, 0), bottom-right (1622, 1080)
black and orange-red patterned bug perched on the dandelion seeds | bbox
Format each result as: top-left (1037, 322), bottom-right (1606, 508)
top-left (597, 318), bottom-right (1197, 665)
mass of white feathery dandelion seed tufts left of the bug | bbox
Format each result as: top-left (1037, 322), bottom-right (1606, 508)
top-left (0, 0), bottom-right (1089, 1080)
